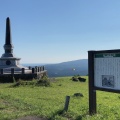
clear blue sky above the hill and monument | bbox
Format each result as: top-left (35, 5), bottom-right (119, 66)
top-left (0, 0), bottom-right (120, 63)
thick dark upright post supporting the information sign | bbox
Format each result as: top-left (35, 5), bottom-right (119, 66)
top-left (88, 51), bottom-right (96, 115)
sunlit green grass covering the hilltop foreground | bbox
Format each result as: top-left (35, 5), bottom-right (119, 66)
top-left (0, 77), bottom-right (120, 120)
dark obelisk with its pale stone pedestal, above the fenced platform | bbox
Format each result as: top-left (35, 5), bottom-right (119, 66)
top-left (0, 17), bottom-right (28, 71)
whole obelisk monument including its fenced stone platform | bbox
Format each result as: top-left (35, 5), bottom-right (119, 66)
top-left (0, 17), bottom-right (47, 83)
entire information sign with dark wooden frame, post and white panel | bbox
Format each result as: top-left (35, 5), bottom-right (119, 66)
top-left (88, 49), bottom-right (120, 115)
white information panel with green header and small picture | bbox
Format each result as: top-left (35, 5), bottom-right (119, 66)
top-left (94, 53), bottom-right (120, 90)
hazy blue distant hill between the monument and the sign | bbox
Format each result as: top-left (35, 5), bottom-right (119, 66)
top-left (44, 59), bottom-right (88, 77)
